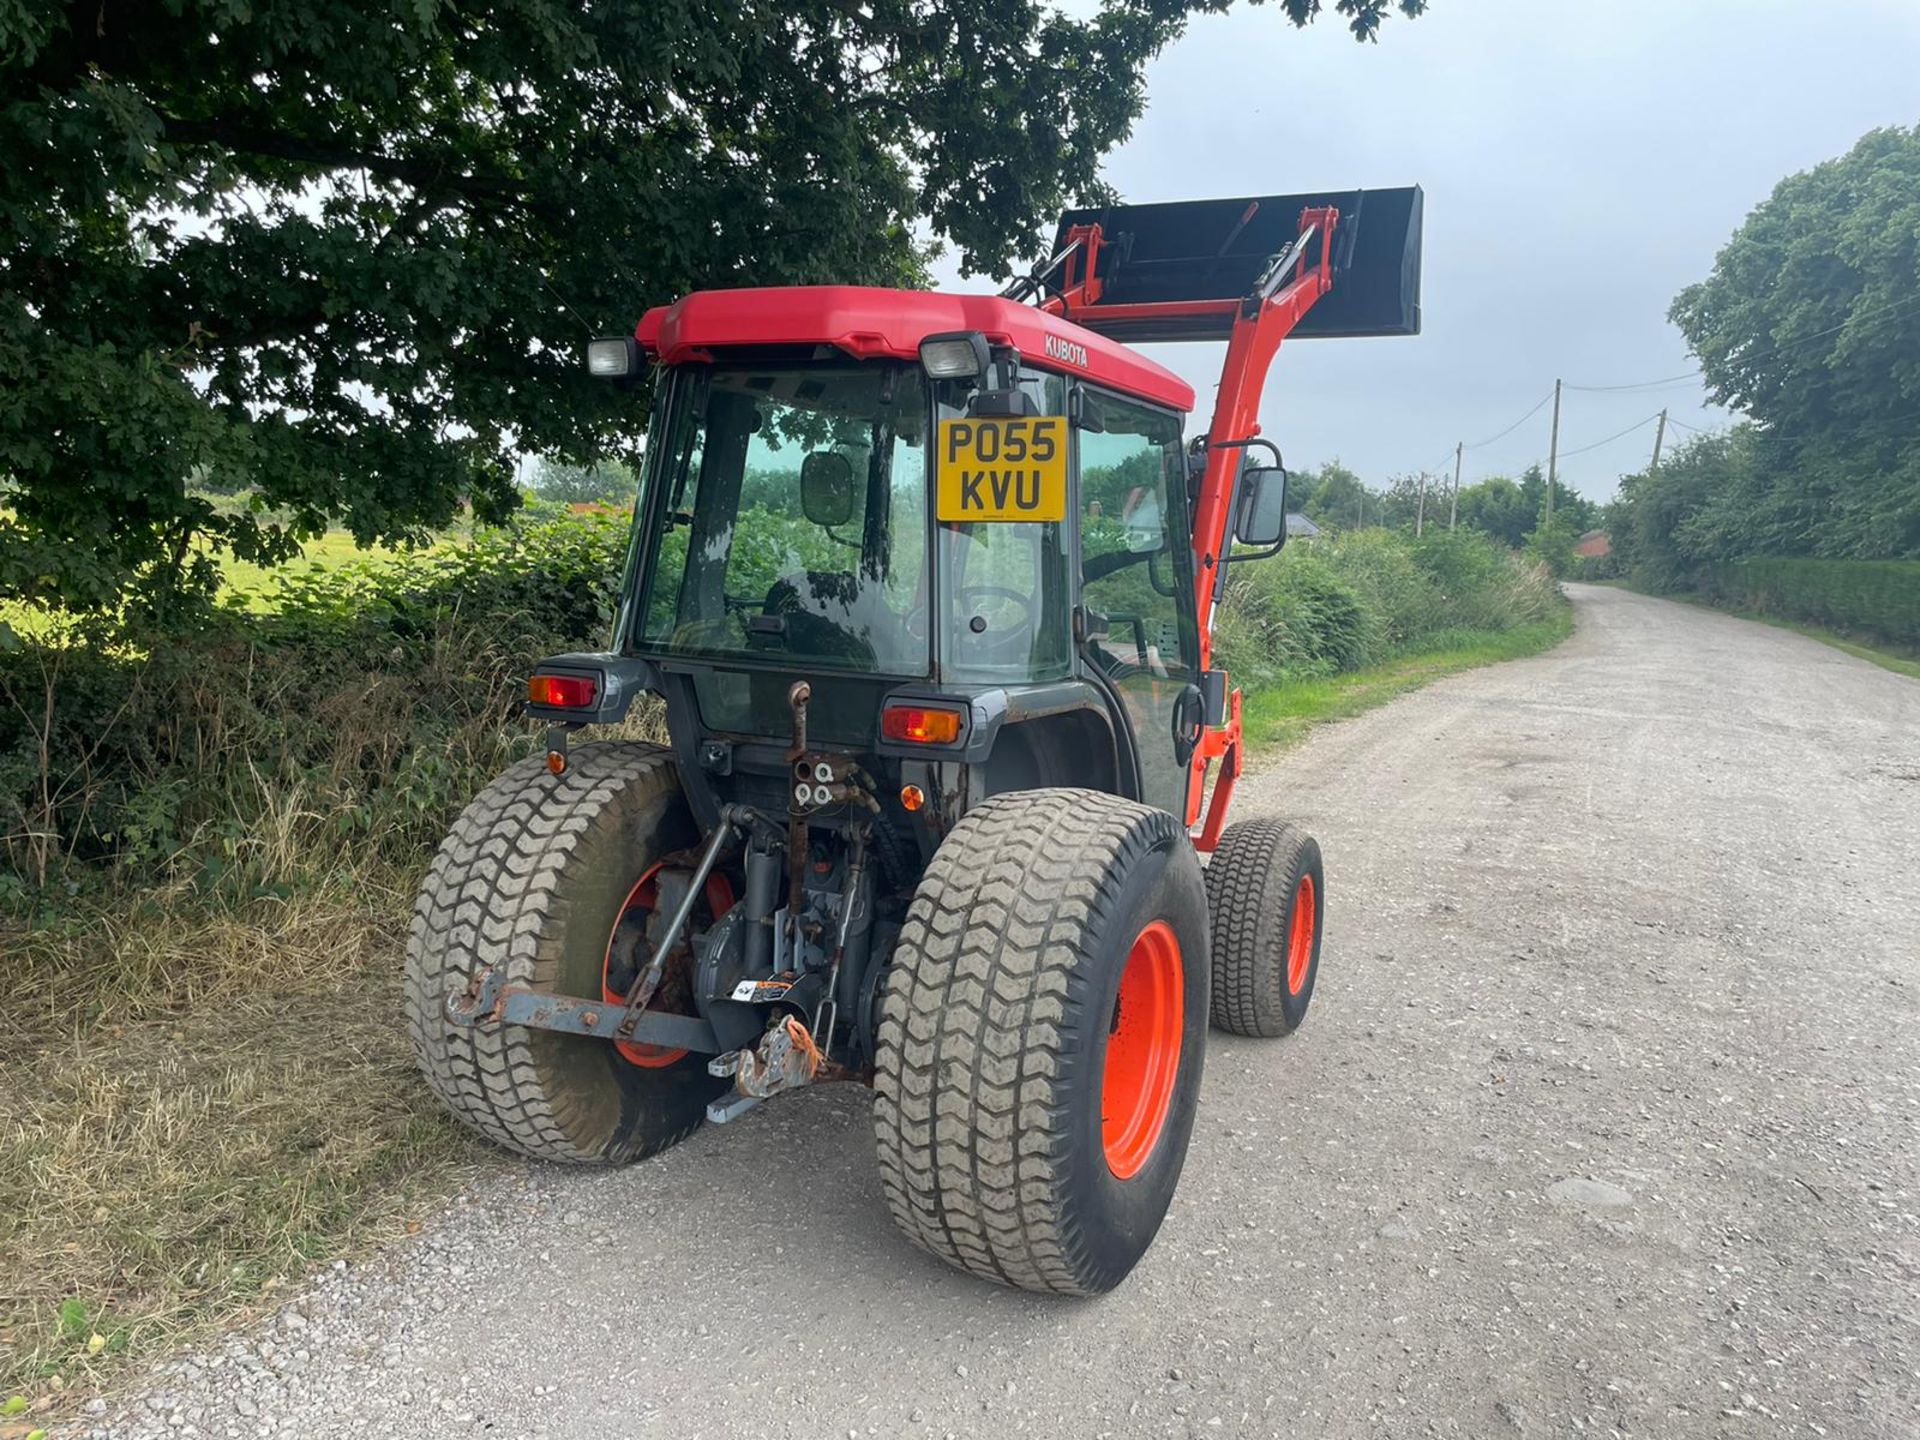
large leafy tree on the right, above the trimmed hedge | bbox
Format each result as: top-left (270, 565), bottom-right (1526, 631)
top-left (1670, 127), bottom-right (1920, 557)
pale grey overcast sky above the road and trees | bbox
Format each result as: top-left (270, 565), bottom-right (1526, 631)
top-left (941, 0), bottom-right (1920, 499)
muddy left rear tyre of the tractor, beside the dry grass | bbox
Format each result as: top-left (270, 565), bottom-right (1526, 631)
top-left (405, 743), bottom-right (728, 1164)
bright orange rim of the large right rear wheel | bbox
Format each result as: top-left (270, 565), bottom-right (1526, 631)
top-left (1100, 920), bottom-right (1187, 1181)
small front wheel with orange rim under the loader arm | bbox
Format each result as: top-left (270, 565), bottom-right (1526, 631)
top-left (1206, 820), bottom-right (1327, 1037)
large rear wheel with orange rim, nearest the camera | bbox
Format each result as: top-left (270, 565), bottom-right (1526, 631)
top-left (874, 789), bottom-right (1208, 1294)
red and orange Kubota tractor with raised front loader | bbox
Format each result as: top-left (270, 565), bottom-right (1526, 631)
top-left (407, 188), bottom-right (1421, 1294)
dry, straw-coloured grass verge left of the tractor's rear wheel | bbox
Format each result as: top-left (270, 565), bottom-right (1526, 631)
top-left (0, 893), bottom-right (486, 1413)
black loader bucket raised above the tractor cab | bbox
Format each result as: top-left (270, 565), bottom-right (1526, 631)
top-left (1054, 184), bottom-right (1423, 342)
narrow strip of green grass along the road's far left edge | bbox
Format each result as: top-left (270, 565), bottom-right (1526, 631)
top-left (1240, 605), bottom-right (1572, 751)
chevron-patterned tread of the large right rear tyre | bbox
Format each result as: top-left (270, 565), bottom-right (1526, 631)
top-left (874, 789), bottom-right (1179, 1294)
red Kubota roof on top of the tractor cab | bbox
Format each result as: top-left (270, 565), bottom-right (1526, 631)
top-left (634, 284), bottom-right (1194, 415)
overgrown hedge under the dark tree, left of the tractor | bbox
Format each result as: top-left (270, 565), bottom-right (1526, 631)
top-left (0, 515), bottom-right (626, 897)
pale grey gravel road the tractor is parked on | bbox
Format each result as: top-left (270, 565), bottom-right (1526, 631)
top-left (67, 588), bottom-right (1920, 1440)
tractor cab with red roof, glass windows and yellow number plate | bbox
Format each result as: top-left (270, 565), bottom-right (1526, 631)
top-left (583, 288), bottom-right (1202, 833)
